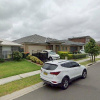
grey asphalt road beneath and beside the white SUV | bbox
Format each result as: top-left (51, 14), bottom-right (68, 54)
top-left (15, 63), bottom-right (100, 100)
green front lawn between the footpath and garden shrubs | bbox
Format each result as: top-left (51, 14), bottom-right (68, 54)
top-left (0, 59), bottom-right (41, 78)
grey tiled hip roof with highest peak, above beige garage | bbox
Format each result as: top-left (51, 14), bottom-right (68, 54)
top-left (14, 34), bottom-right (60, 44)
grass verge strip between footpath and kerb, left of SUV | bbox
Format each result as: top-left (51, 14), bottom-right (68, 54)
top-left (0, 74), bottom-right (41, 96)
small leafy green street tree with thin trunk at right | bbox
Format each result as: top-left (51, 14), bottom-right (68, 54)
top-left (85, 39), bottom-right (100, 62)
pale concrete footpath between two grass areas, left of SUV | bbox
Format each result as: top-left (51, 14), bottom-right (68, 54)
top-left (0, 70), bottom-right (41, 85)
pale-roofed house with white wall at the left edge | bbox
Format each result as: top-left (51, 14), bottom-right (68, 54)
top-left (0, 39), bottom-right (21, 59)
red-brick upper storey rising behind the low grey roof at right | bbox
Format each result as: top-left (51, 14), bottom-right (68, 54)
top-left (68, 36), bottom-right (91, 44)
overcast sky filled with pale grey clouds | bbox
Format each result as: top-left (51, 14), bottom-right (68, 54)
top-left (0, 0), bottom-right (100, 41)
